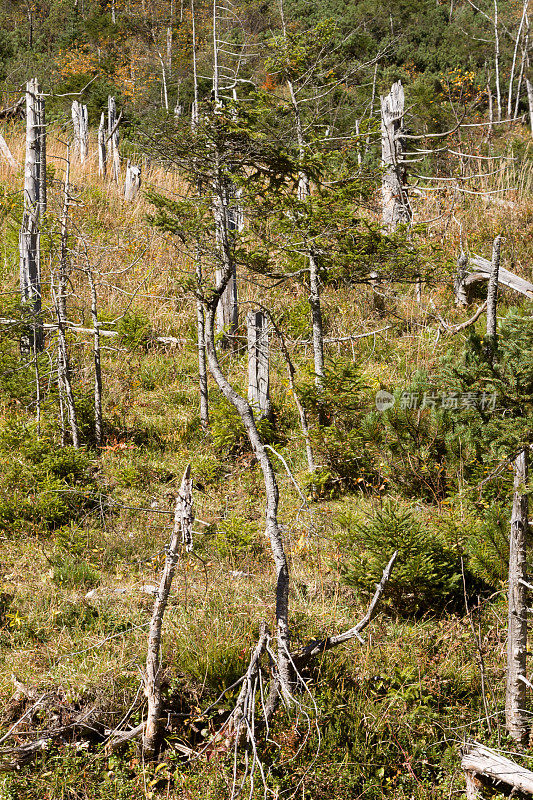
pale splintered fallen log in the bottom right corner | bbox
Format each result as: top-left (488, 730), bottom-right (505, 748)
top-left (461, 742), bottom-right (533, 800)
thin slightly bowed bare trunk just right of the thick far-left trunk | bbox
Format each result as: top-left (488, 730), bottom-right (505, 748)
top-left (56, 148), bottom-right (80, 449)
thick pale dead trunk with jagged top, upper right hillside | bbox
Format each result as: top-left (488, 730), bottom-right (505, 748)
top-left (381, 81), bottom-right (411, 230)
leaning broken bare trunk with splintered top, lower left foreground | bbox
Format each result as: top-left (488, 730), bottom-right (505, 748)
top-left (143, 465), bottom-right (193, 759)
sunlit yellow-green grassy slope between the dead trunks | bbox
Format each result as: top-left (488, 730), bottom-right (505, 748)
top-left (0, 122), bottom-right (532, 800)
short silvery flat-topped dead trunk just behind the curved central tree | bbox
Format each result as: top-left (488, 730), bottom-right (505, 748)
top-left (246, 311), bottom-right (272, 417)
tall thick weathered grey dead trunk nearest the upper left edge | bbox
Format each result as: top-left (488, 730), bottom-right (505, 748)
top-left (19, 78), bottom-right (46, 351)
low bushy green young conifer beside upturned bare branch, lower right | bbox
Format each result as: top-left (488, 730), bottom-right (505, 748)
top-left (339, 500), bottom-right (463, 615)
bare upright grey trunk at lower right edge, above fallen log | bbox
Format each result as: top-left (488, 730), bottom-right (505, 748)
top-left (505, 450), bottom-right (529, 744)
